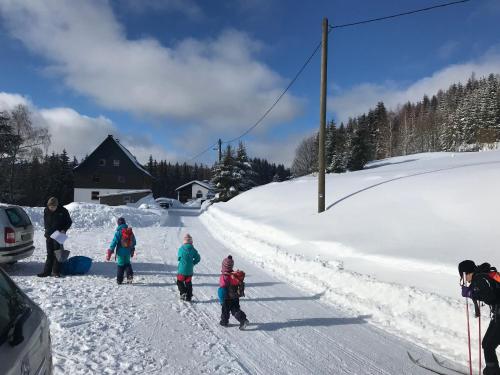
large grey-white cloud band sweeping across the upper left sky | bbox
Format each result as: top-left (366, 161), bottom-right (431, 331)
top-left (0, 0), bottom-right (301, 133)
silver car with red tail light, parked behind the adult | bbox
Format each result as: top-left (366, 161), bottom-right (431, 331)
top-left (0, 204), bottom-right (35, 263)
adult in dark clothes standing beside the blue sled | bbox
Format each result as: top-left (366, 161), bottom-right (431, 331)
top-left (37, 197), bottom-right (73, 277)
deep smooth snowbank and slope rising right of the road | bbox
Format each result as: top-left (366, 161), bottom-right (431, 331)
top-left (202, 151), bottom-right (500, 368)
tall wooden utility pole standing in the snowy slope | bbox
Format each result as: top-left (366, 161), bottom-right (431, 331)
top-left (318, 17), bottom-right (328, 213)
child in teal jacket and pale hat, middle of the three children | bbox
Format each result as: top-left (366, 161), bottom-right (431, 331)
top-left (177, 233), bottom-right (201, 302)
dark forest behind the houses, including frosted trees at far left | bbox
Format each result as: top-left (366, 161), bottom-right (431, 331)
top-left (0, 105), bottom-right (290, 206)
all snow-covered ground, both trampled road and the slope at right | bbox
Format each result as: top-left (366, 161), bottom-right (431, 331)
top-left (6, 152), bottom-right (500, 374)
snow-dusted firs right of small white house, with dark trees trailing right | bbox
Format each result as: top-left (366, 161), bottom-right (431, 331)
top-left (211, 142), bottom-right (290, 202)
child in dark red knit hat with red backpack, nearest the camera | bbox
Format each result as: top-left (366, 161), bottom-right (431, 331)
top-left (218, 255), bottom-right (248, 330)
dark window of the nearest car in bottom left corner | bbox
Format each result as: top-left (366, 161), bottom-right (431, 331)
top-left (0, 272), bottom-right (25, 345)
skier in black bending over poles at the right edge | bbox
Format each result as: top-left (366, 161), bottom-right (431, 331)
top-left (458, 260), bottom-right (500, 375)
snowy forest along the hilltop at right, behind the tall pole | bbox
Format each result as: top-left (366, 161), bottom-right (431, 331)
top-left (292, 74), bottom-right (500, 176)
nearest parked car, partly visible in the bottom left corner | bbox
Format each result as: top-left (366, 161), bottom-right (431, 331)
top-left (0, 268), bottom-right (52, 375)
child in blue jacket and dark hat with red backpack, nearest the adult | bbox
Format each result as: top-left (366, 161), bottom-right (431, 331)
top-left (106, 217), bottom-right (136, 285)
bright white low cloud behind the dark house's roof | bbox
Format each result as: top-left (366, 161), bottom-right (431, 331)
top-left (0, 92), bottom-right (176, 163)
